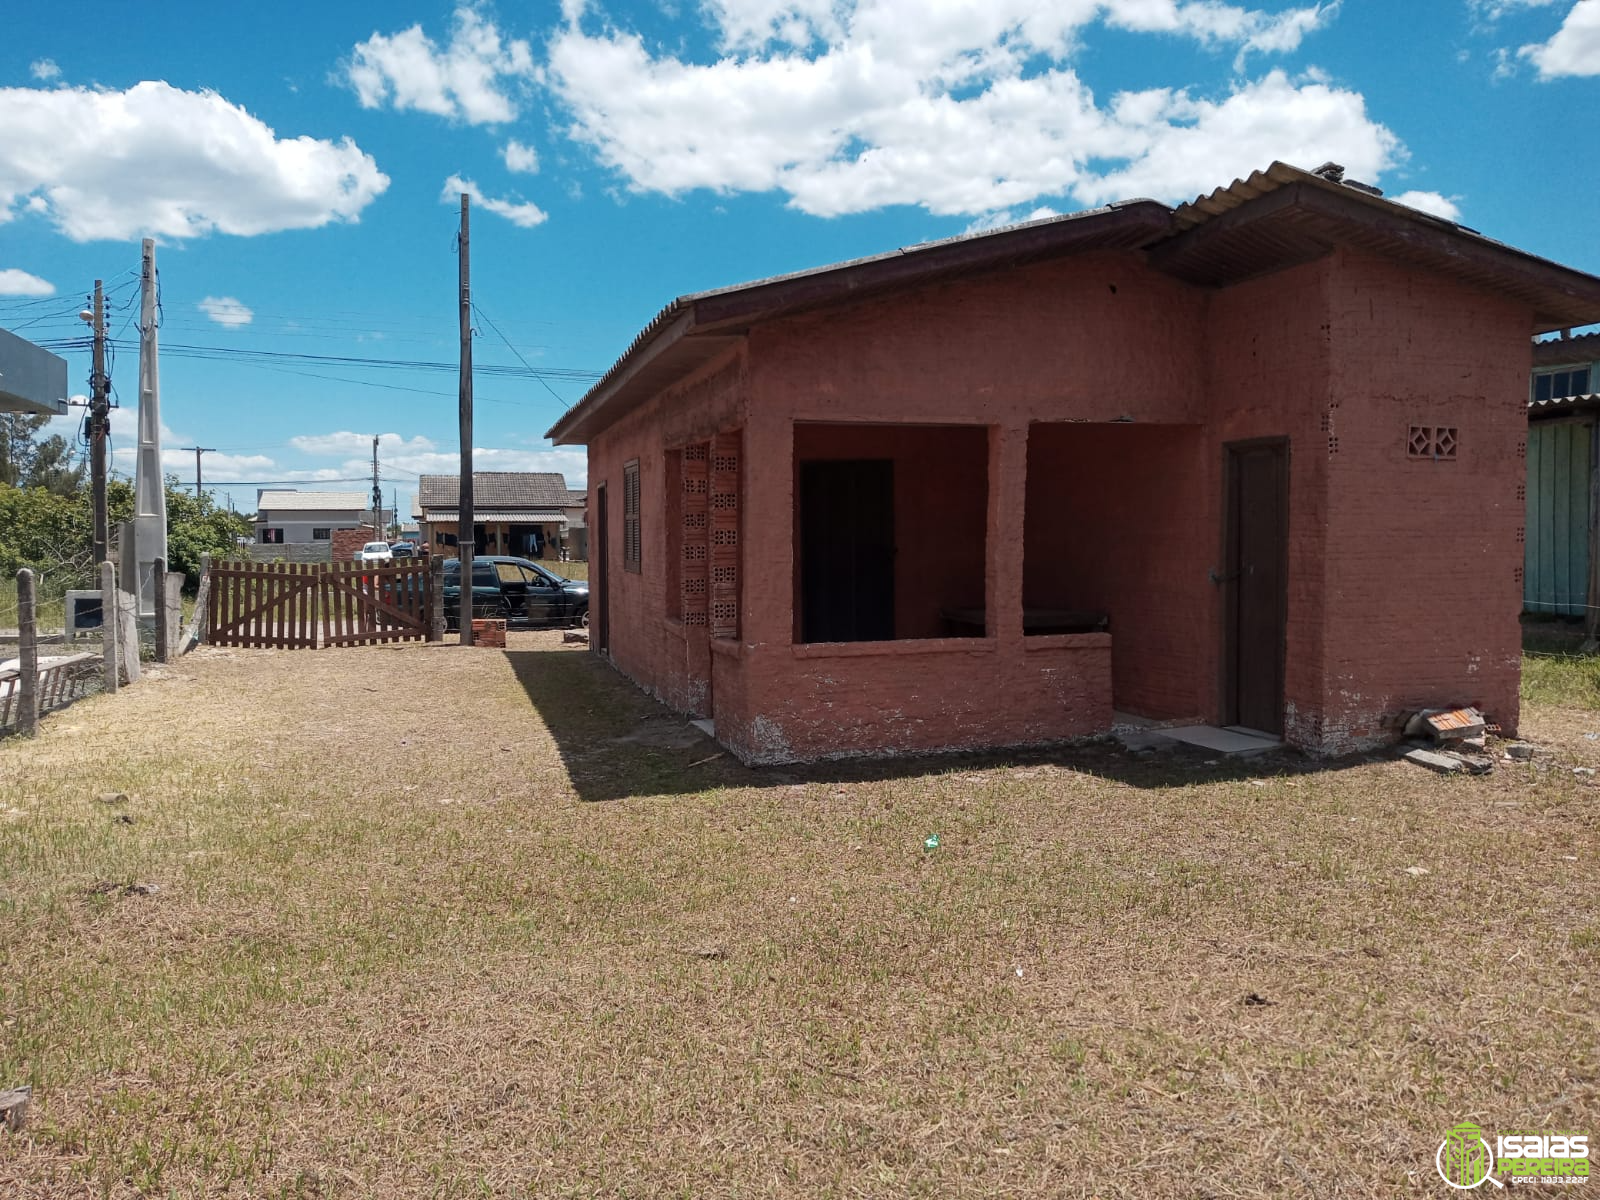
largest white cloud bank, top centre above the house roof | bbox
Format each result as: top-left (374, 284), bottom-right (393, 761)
top-left (547, 0), bottom-right (1402, 216)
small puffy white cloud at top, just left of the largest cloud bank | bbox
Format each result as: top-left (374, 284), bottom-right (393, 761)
top-left (344, 5), bottom-right (534, 125)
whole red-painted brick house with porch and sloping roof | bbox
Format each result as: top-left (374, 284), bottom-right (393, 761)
top-left (550, 163), bottom-right (1600, 762)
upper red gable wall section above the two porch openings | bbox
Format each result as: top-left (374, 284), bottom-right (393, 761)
top-left (749, 253), bottom-right (1205, 424)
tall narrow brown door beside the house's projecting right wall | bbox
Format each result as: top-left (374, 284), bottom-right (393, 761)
top-left (1222, 440), bottom-right (1290, 734)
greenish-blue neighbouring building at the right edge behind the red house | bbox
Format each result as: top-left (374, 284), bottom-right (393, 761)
top-left (1522, 333), bottom-right (1600, 624)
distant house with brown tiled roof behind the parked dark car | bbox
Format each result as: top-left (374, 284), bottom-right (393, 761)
top-left (416, 470), bottom-right (589, 558)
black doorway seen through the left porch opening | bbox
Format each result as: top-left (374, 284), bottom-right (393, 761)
top-left (798, 459), bottom-right (894, 642)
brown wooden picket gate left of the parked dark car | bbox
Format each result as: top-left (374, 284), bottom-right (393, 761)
top-left (206, 562), bottom-right (432, 650)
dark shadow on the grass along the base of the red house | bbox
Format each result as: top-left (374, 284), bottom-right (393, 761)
top-left (506, 650), bottom-right (1389, 802)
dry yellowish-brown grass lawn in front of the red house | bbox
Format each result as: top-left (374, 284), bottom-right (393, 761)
top-left (0, 634), bottom-right (1600, 1200)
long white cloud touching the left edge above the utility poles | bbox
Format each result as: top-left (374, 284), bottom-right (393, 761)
top-left (0, 82), bottom-right (389, 242)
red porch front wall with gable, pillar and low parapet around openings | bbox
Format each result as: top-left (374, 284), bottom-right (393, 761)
top-left (715, 254), bottom-right (1205, 762)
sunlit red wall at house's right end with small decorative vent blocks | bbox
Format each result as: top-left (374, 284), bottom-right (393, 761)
top-left (1320, 253), bottom-right (1533, 750)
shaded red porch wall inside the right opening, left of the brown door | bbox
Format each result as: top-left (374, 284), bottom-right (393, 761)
top-left (1022, 424), bottom-right (1211, 717)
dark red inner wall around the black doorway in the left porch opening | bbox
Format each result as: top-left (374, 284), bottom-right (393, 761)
top-left (795, 426), bottom-right (989, 638)
